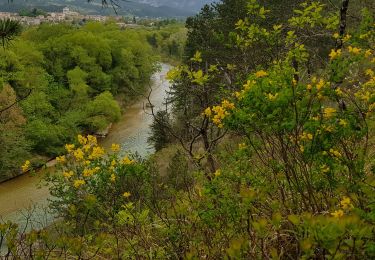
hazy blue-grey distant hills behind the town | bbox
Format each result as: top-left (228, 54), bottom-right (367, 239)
top-left (0, 0), bottom-right (214, 18)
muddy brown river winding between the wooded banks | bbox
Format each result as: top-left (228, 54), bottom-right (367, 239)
top-left (0, 64), bottom-right (171, 226)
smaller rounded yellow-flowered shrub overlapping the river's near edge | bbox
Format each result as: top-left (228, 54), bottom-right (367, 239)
top-left (47, 135), bottom-right (146, 230)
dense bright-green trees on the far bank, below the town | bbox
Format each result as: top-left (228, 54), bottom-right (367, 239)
top-left (0, 20), bottom-right (185, 181)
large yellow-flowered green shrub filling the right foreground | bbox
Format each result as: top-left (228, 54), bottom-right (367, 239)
top-left (217, 49), bottom-right (375, 258)
